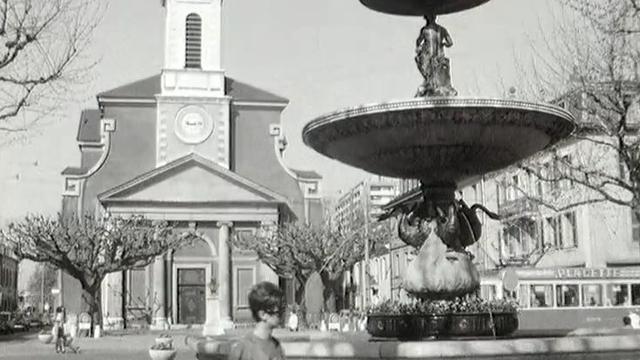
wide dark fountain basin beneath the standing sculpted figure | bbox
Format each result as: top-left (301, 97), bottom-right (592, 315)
top-left (302, 98), bottom-right (575, 187)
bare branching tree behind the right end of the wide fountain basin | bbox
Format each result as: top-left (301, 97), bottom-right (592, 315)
top-left (504, 0), bottom-right (640, 219)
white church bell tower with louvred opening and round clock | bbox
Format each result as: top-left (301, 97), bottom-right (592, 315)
top-left (156, 0), bottom-right (230, 168)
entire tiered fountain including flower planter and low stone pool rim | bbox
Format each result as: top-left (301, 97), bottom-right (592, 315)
top-left (191, 0), bottom-right (640, 359)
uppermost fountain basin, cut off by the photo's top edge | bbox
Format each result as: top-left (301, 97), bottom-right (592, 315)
top-left (360, 0), bottom-right (489, 16)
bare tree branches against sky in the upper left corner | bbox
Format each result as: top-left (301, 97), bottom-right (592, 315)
top-left (0, 0), bottom-right (105, 134)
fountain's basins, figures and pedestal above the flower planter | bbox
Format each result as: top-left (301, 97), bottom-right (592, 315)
top-left (303, 0), bottom-right (575, 338)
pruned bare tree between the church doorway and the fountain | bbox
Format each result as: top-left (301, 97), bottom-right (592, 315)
top-left (233, 222), bottom-right (393, 312)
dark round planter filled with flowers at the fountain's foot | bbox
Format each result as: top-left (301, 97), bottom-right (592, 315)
top-left (367, 298), bottom-right (518, 339)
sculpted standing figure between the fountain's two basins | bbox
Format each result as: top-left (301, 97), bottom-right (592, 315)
top-left (415, 14), bottom-right (458, 97)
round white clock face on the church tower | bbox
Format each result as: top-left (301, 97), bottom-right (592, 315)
top-left (175, 106), bottom-right (213, 144)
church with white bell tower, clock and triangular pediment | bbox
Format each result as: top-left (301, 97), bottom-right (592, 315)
top-left (60, 0), bottom-right (322, 335)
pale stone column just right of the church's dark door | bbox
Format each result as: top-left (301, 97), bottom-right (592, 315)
top-left (218, 222), bottom-right (233, 329)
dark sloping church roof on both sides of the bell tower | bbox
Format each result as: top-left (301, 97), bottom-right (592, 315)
top-left (98, 74), bottom-right (289, 103)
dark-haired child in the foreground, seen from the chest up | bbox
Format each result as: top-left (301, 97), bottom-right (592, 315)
top-left (228, 281), bottom-right (285, 360)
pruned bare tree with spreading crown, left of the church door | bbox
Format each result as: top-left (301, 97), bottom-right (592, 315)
top-left (0, 216), bottom-right (197, 329)
